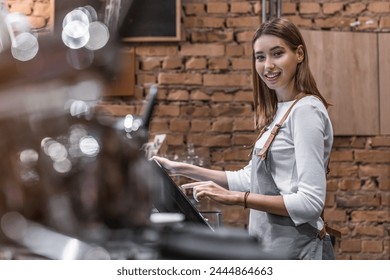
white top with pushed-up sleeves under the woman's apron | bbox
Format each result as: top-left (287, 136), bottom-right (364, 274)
top-left (226, 96), bottom-right (333, 229)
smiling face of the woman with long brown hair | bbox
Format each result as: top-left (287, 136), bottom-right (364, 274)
top-left (253, 35), bottom-right (303, 101)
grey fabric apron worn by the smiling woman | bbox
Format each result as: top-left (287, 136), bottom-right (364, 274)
top-left (249, 148), bottom-right (323, 259)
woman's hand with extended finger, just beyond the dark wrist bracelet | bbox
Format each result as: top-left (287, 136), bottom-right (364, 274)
top-left (181, 181), bottom-right (244, 205)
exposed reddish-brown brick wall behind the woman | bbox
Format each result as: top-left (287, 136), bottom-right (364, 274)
top-left (9, 0), bottom-right (390, 259)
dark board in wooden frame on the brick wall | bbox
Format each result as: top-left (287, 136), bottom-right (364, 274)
top-left (119, 0), bottom-right (181, 42)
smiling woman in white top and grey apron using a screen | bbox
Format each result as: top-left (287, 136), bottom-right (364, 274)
top-left (156, 18), bottom-right (333, 259)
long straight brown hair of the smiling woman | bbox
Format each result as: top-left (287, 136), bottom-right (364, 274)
top-left (252, 18), bottom-right (330, 129)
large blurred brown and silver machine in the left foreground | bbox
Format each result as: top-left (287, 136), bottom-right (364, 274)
top-left (0, 1), bottom-right (278, 259)
